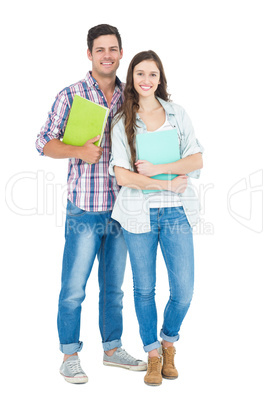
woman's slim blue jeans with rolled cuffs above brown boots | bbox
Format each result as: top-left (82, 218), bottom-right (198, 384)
top-left (123, 207), bottom-right (194, 352)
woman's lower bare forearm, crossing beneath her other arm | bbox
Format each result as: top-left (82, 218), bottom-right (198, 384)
top-left (114, 166), bottom-right (187, 193)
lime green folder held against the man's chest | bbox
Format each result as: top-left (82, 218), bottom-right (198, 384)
top-left (62, 95), bottom-right (110, 146)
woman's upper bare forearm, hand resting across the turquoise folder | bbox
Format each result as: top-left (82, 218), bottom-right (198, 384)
top-left (135, 152), bottom-right (203, 176)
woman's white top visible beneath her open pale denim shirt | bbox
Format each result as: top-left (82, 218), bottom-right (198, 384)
top-left (144, 114), bottom-right (182, 208)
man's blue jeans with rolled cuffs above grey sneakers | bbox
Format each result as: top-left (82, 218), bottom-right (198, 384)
top-left (58, 201), bottom-right (127, 354)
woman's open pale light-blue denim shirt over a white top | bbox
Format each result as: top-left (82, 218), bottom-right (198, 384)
top-left (109, 98), bottom-right (203, 233)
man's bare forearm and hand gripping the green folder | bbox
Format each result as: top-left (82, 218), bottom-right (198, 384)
top-left (44, 135), bottom-right (103, 163)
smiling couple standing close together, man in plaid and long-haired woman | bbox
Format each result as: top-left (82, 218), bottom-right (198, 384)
top-left (36, 24), bottom-right (202, 385)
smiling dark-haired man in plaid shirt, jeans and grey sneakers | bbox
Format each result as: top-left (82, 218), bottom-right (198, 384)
top-left (36, 24), bottom-right (146, 383)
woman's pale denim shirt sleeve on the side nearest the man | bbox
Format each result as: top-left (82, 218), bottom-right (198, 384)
top-left (109, 119), bottom-right (133, 176)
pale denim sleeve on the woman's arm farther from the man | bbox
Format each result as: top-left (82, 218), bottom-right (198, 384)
top-left (181, 109), bottom-right (204, 179)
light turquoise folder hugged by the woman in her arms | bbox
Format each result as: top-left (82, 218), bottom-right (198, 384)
top-left (136, 129), bottom-right (181, 193)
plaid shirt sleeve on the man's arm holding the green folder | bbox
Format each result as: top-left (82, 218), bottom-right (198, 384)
top-left (35, 90), bottom-right (70, 155)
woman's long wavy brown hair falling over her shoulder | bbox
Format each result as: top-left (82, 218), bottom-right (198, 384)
top-left (114, 50), bottom-right (169, 172)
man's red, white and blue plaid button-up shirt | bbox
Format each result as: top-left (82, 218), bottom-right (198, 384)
top-left (36, 72), bottom-right (123, 212)
